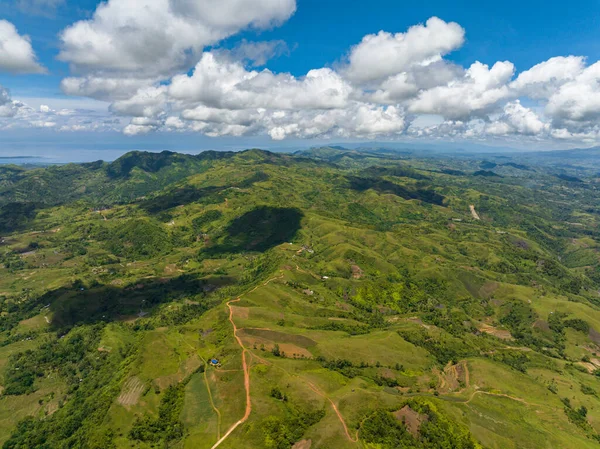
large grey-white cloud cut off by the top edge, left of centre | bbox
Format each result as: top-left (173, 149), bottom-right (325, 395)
top-left (59, 0), bottom-right (296, 77)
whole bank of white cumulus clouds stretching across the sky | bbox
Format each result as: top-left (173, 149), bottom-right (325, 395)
top-left (0, 8), bottom-right (600, 142)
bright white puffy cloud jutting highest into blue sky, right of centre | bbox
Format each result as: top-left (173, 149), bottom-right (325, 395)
top-left (346, 17), bottom-right (465, 84)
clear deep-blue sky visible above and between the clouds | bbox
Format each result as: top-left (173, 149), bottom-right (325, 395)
top-left (0, 0), bottom-right (600, 97)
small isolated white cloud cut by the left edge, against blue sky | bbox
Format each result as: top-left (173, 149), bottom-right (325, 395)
top-left (0, 20), bottom-right (46, 73)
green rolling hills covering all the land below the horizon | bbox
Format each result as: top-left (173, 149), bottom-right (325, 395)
top-left (0, 147), bottom-right (600, 449)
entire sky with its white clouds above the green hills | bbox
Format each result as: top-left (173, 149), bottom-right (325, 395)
top-left (0, 0), bottom-right (600, 161)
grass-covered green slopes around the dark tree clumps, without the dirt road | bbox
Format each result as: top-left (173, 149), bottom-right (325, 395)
top-left (0, 152), bottom-right (600, 448)
